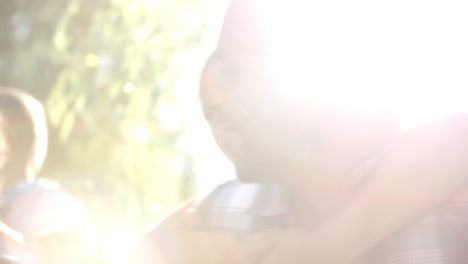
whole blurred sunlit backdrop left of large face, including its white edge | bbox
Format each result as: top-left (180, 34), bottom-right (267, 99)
top-left (0, 0), bottom-right (232, 250)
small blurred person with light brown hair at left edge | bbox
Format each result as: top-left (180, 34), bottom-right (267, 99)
top-left (0, 88), bottom-right (93, 263)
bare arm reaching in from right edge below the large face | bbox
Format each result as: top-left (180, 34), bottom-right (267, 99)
top-left (251, 115), bottom-right (468, 264)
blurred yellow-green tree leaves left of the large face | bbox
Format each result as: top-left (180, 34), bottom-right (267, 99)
top-left (4, 0), bottom-right (214, 227)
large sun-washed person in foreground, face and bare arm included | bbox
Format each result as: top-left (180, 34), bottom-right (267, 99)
top-left (128, 0), bottom-right (468, 264)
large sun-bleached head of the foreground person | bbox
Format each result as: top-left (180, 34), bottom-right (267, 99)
top-left (200, 0), bottom-right (398, 184)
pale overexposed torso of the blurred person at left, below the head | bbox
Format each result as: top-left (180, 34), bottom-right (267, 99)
top-left (2, 179), bottom-right (94, 263)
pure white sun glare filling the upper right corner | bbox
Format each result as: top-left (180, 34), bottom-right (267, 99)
top-left (262, 0), bottom-right (468, 129)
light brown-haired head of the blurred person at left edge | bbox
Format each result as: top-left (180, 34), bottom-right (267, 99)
top-left (0, 88), bottom-right (47, 184)
